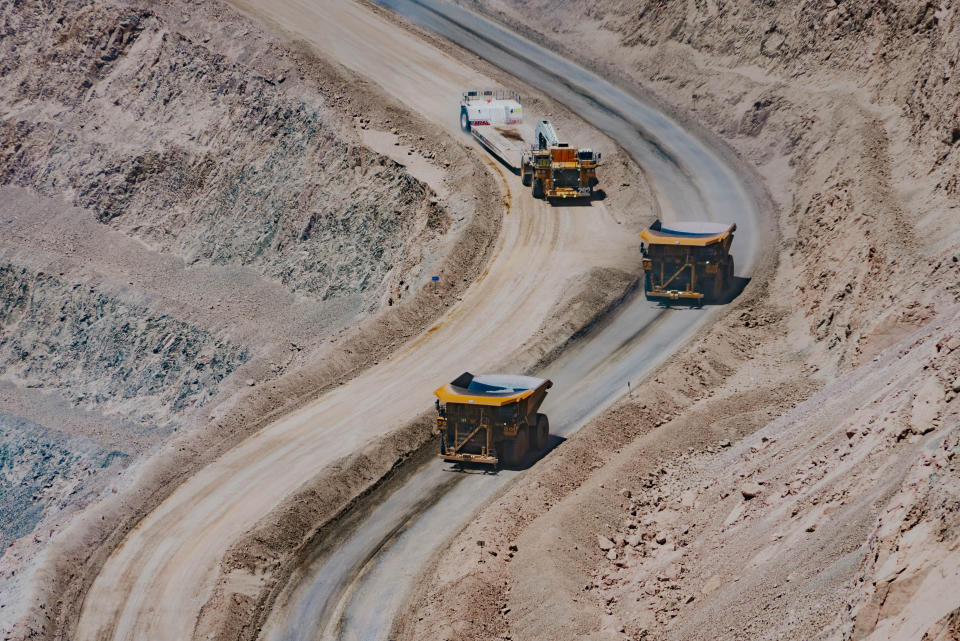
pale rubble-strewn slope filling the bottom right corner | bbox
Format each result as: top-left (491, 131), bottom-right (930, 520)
top-left (588, 310), bottom-right (960, 639)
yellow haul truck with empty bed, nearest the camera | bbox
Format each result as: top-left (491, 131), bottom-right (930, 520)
top-left (434, 372), bottom-right (553, 467)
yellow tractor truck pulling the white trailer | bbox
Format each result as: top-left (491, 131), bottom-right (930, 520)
top-left (520, 120), bottom-right (600, 200)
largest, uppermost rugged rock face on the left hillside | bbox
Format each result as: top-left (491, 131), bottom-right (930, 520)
top-left (0, 0), bottom-right (448, 310)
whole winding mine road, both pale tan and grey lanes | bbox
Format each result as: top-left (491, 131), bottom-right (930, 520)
top-left (74, 0), bottom-right (761, 641)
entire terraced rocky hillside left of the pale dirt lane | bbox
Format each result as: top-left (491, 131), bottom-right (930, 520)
top-left (0, 2), bottom-right (510, 637)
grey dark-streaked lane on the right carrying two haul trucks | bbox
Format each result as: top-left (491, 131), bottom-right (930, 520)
top-left (244, 0), bottom-right (765, 641)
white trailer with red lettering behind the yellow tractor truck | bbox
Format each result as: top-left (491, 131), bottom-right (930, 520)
top-left (460, 89), bottom-right (533, 171)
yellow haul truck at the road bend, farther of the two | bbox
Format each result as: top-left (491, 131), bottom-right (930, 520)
top-left (640, 220), bottom-right (737, 306)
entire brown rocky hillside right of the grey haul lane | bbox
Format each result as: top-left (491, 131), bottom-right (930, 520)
top-left (400, 2), bottom-right (960, 639)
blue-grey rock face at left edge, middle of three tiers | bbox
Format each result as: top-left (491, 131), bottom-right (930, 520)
top-left (0, 265), bottom-right (250, 433)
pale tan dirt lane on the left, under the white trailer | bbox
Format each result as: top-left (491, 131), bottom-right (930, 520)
top-left (71, 1), bottom-right (638, 641)
